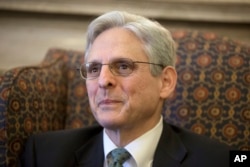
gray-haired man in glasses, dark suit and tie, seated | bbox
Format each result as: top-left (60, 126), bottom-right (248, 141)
top-left (20, 11), bottom-right (229, 167)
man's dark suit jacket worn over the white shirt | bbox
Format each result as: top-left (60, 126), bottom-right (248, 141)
top-left (22, 123), bottom-right (230, 167)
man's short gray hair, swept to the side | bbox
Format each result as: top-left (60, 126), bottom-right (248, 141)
top-left (85, 11), bottom-right (176, 76)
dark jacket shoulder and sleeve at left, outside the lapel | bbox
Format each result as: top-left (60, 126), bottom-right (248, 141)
top-left (21, 126), bottom-right (103, 167)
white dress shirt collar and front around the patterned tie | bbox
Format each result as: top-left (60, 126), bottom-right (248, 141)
top-left (103, 117), bottom-right (163, 167)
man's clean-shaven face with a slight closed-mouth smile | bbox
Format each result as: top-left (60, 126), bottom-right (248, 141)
top-left (86, 28), bottom-right (166, 130)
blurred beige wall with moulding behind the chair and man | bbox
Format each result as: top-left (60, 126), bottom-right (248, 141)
top-left (0, 0), bottom-right (250, 71)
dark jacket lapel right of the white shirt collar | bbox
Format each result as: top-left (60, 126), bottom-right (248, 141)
top-left (153, 122), bottom-right (187, 167)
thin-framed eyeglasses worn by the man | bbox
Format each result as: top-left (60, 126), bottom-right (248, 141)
top-left (79, 58), bottom-right (164, 79)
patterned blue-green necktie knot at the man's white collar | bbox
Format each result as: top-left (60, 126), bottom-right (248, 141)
top-left (107, 148), bottom-right (131, 167)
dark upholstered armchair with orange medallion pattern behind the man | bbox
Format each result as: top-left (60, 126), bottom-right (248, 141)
top-left (0, 31), bottom-right (250, 167)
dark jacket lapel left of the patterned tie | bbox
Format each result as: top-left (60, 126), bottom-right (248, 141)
top-left (75, 127), bottom-right (104, 167)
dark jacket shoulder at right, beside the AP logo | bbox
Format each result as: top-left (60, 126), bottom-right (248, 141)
top-left (170, 125), bottom-right (234, 167)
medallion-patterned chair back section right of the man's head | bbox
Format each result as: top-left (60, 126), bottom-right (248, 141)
top-left (163, 31), bottom-right (250, 150)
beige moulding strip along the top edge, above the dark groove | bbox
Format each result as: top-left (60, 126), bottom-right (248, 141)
top-left (0, 0), bottom-right (250, 23)
